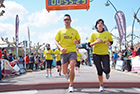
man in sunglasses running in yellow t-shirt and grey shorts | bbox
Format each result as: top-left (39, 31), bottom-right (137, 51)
top-left (55, 14), bottom-right (81, 92)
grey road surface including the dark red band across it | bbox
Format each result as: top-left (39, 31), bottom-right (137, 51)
top-left (0, 65), bottom-right (140, 94)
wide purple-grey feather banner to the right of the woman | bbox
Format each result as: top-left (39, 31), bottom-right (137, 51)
top-left (115, 11), bottom-right (126, 46)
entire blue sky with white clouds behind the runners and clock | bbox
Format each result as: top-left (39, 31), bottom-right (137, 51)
top-left (0, 0), bottom-right (140, 48)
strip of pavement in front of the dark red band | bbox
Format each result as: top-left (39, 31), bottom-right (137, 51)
top-left (0, 88), bottom-right (140, 94)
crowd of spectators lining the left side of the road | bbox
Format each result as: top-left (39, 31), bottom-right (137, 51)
top-left (0, 48), bottom-right (44, 71)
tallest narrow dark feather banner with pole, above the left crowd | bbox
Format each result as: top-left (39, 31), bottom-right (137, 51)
top-left (15, 15), bottom-right (19, 58)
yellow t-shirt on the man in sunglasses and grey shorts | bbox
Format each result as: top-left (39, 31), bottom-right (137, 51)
top-left (55, 27), bottom-right (81, 53)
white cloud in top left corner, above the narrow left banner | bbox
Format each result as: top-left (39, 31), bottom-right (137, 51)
top-left (0, 1), bottom-right (28, 20)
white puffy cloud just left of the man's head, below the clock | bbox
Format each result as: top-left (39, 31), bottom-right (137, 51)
top-left (28, 9), bottom-right (63, 27)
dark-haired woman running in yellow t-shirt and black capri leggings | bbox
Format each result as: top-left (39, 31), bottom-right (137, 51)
top-left (88, 19), bottom-right (113, 92)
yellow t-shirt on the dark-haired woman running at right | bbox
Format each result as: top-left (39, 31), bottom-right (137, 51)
top-left (88, 31), bottom-right (113, 55)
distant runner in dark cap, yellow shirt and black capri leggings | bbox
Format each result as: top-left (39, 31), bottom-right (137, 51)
top-left (44, 44), bottom-right (54, 77)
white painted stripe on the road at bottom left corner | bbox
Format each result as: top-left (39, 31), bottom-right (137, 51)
top-left (0, 90), bottom-right (38, 94)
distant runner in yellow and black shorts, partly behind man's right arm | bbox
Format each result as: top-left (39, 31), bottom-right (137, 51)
top-left (54, 49), bottom-right (61, 76)
